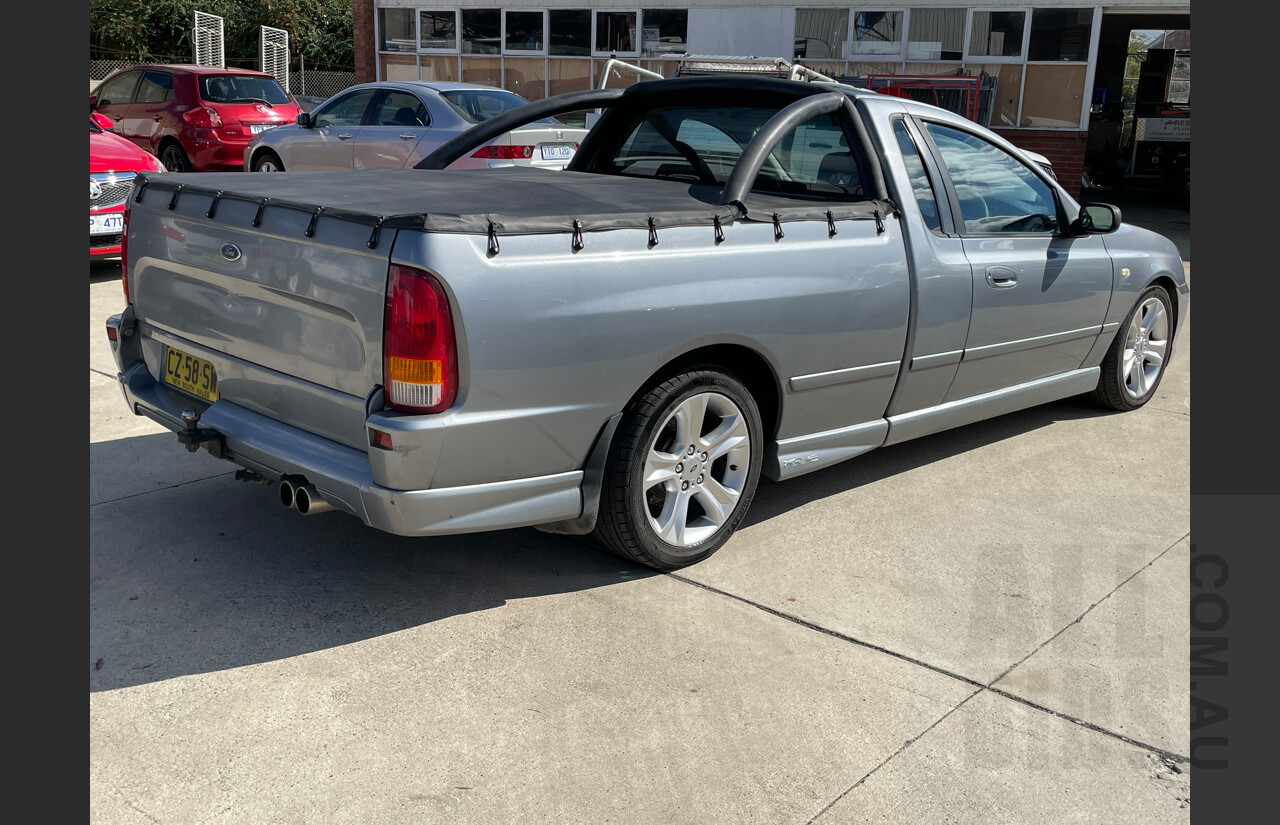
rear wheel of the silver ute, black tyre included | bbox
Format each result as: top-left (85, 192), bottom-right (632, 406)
top-left (593, 365), bottom-right (763, 570)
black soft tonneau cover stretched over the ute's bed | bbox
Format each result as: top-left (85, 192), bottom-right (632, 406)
top-left (133, 168), bottom-right (896, 247)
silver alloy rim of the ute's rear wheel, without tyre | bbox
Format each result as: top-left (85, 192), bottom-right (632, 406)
top-left (641, 393), bottom-right (751, 547)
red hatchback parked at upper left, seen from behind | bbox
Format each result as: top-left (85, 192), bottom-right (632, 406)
top-left (88, 64), bottom-right (302, 171)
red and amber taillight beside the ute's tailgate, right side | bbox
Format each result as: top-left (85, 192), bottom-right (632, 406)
top-left (383, 265), bottom-right (458, 413)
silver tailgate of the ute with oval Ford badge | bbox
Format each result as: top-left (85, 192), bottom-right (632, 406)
top-left (129, 191), bottom-right (390, 449)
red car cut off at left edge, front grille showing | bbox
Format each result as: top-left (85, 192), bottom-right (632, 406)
top-left (88, 114), bottom-right (165, 260)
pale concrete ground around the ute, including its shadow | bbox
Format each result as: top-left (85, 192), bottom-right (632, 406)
top-left (90, 198), bottom-right (1190, 825)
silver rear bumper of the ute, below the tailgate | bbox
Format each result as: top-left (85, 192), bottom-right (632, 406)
top-left (108, 310), bottom-right (582, 536)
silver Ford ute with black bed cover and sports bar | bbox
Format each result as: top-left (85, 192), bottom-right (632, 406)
top-left (106, 75), bottom-right (1189, 570)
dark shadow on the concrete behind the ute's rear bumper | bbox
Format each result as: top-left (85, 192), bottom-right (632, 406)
top-left (90, 434), bottom-right (655, 692)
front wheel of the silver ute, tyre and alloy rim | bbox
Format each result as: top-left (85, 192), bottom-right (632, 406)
top-left (1091, 287), bottom-right (1174, 411)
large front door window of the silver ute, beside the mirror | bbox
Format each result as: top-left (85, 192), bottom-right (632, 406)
top-left (924, 123), bottom-right (1057, 234)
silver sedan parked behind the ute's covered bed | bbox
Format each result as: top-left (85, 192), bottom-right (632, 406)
top-left (244, 81), bottom-right (586, 171)
